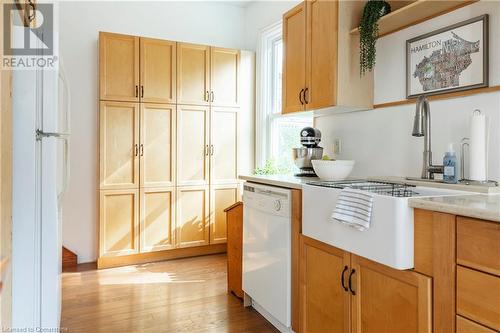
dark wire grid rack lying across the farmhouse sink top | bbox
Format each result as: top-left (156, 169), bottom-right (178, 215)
top-left (307, 180), bottom-right (419, 198)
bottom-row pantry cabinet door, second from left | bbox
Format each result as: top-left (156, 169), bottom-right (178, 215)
top-left (140, 188), bottom-right (175, 252)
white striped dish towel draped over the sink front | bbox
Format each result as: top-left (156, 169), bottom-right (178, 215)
top-left (331, 188), bottom-right (373, 231)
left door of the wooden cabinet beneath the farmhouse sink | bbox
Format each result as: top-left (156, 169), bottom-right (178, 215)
top-left (299, 236), bottom-right (350, 333)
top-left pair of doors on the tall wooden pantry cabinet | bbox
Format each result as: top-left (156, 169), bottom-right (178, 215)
top-left (99, 32), bottom-right (177, 103)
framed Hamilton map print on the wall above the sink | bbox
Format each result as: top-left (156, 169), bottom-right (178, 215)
top-left (406, 15), bottom-right (488, 98)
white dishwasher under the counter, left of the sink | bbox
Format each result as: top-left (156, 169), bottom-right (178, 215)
top-left (243, 182), bottom-right (291, 332)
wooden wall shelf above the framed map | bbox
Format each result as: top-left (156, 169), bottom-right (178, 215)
top-left (350, 0), bottom-right (479, 37)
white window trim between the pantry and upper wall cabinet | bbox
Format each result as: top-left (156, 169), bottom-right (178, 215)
top-left (255, 20), bottom-right (283, 167)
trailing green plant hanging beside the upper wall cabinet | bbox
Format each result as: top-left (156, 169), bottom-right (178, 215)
top-left (359, 0), bottom-right (391, 75)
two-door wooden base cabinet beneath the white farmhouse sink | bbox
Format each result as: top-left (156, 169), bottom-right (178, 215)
top-left (300, 236), bottom-right (432, 333)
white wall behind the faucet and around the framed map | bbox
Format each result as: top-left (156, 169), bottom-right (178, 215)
top-left (316, 1), bottom-right (500, 180)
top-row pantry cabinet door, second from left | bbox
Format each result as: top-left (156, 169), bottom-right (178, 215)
top-left (140, 37), bottom-right (177, 103)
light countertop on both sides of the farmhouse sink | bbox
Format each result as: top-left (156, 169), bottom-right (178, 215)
top-left (239, 175), bottom-right (500, 222)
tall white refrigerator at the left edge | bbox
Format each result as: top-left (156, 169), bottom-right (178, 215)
top-left (12, 13), bottom-right (70, 332)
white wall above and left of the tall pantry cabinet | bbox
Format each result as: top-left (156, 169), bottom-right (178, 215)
top-left (60, 1), bottom-right (253, 262)
